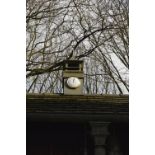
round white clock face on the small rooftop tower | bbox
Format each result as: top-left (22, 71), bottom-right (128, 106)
top-left (67, 77), bottom-right (81, 88)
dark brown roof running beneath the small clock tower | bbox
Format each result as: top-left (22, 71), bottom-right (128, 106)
top-left (26, 94), bottom-right (129, 121)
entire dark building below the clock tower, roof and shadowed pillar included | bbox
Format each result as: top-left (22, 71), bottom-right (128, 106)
top-left (26, 94), bottom-right (129, 155)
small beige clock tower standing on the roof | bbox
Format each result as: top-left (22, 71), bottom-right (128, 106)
top-left (63, 60), bottom-right (84, 95)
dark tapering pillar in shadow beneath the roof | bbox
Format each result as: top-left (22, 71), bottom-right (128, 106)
top-left (90, 122), bottom-right (110, 155)
